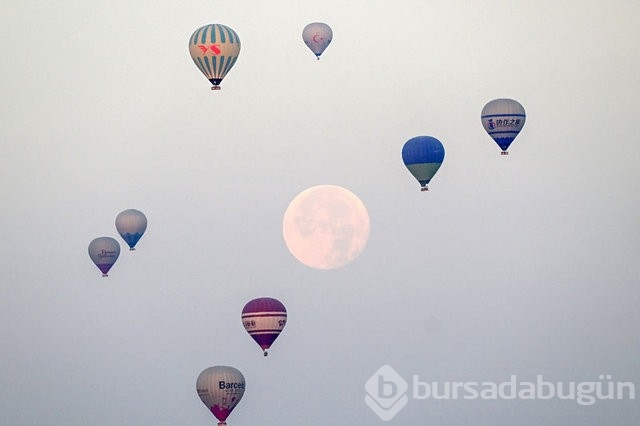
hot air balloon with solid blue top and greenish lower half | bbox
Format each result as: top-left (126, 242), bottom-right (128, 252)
top-left (402, 136), bottom-right (444, 191)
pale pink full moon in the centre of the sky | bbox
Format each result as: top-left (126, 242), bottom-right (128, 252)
top-left (282, 185), bottom-right (369, 269)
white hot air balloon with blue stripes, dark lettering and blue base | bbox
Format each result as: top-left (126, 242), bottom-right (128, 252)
top-left (480, 99), bottom-right (526, 155)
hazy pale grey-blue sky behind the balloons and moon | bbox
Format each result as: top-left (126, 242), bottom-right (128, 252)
top-left (0, 0), bottom-right (640, 426)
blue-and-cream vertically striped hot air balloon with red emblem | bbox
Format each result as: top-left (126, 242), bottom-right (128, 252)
top-left (189, 24), bottom-right (240, 90)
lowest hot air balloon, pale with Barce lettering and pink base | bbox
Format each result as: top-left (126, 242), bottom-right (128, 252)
top-left (196, 365), bottom-right (245, 426)
